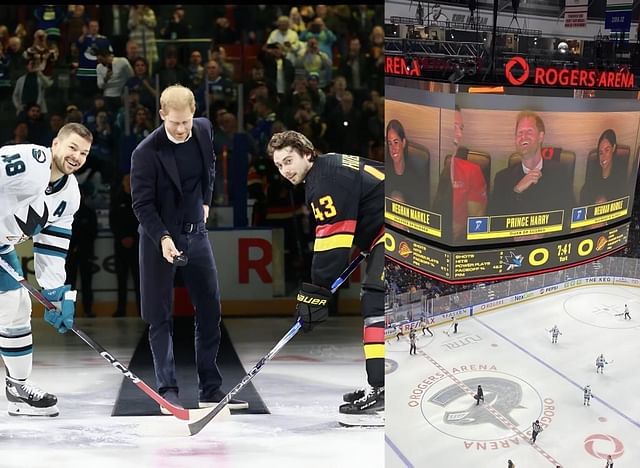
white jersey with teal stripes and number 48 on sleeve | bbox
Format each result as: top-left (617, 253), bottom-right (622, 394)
top-left (0, 145), bottom-right (80, 289)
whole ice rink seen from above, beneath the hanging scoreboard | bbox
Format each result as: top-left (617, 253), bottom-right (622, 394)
top-left (385, 285), bottom-right (640, 468)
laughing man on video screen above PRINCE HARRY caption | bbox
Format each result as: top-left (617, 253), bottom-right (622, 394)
top-left (490, 111), bottom-right (574, 219)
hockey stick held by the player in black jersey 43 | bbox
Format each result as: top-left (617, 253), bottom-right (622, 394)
top-left (189, 252), bottom-right (368, 435)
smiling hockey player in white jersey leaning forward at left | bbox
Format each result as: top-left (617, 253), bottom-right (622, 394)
top-left (0, 123), bottom-right (93, 416)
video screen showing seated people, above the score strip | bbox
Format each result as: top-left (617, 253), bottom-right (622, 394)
top-left (385, 90), bottom-right (640, 247)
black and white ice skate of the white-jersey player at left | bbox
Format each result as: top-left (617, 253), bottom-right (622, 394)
top-left (6, 377), bottom-right (59, 417)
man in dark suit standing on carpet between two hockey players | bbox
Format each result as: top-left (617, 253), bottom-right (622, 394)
top-left (131, 85), bottom-right (248, 414)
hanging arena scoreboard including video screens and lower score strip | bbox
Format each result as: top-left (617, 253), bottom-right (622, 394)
top-left (385, 86), bottom-right (640, 283)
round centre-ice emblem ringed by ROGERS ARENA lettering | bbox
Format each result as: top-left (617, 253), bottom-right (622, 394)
top-left (407, 364), bottom-right (555, 451)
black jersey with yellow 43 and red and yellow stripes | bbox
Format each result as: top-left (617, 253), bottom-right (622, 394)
top-left (304, 153), bottom-right (384, 289)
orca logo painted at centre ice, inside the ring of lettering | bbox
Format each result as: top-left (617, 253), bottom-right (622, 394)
top-left (429, 377), bottom-right (523, 429)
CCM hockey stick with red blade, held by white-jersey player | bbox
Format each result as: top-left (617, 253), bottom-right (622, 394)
top-left (0, 257), bottom-right (216, 421)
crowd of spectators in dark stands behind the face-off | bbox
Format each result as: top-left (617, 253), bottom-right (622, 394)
top-left (0, 5), bottom-right (384, 315)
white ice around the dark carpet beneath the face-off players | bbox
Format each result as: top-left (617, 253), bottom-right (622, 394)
top-left (0, 317), bottom-right (384, 468)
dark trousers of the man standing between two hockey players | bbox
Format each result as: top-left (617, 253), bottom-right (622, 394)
top-left (140, 224), bottom-right (222, 399)
